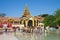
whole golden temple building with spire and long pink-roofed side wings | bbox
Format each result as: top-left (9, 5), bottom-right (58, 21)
top-left (0, 6), bottom-right (43, 27)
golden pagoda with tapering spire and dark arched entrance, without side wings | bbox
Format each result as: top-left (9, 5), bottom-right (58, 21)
top-left (20, 5), bottom-right (37, 27)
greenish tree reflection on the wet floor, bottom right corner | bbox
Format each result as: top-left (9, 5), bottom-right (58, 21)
top-left (44, 33), bottom-right (60, 40)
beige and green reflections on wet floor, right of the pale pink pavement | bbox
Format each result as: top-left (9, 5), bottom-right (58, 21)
top-left (16, 32), bottom-right (60, 40)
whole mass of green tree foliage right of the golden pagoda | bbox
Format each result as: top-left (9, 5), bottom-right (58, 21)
top-left (43, 9), bottom-right (60, 27)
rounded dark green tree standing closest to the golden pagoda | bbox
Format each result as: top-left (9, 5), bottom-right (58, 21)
top-left (43, 15), bottom-right (55, 26)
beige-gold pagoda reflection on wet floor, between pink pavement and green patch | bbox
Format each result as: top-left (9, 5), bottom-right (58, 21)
top-left (16, 32), bottom-right (43, 40)
